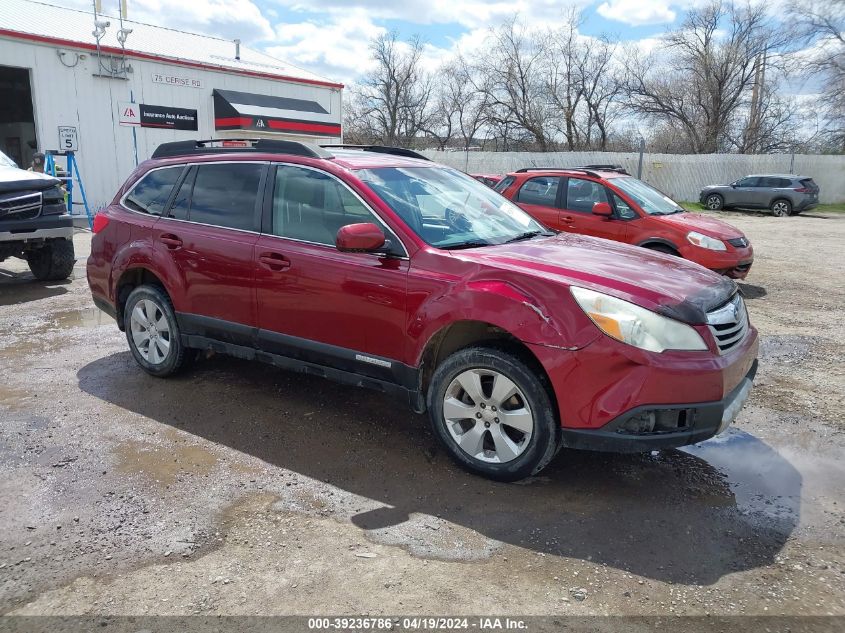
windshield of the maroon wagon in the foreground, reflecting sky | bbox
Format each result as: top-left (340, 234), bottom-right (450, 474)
top-left (357, 167), bottom-right (551, 248)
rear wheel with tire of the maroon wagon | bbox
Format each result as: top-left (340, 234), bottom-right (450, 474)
top-left (123, 285), bottom-right (190, 378)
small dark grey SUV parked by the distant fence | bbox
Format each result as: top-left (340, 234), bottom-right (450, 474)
top-left (698, 174), bottom-right (819, 217)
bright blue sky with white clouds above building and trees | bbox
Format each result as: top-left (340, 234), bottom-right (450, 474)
top-left (52, 0), bottom-right (728, 84)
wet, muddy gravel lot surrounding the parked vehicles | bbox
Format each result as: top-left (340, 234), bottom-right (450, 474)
top-left (0, 213), bottom-right (845, 623)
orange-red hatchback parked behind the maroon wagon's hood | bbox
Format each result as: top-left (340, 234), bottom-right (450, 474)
top-left (495, 167), bottom-right (754, 279)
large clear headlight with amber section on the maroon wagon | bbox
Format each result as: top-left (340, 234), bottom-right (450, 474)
top-left (570, 286), bottom-right (707, 352)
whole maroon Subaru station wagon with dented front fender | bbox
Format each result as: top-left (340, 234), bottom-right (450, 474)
top-left (87, 140), bottom-right (758, 481)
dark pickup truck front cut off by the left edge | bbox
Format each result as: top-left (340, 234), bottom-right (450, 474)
top-left (0, 152), bottom-right (75, 280)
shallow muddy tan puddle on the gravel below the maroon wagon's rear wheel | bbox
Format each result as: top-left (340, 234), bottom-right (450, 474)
top-left (115, 440), bottom-right (218, 487)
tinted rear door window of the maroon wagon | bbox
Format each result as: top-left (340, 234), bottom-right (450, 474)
top-left (186, 163), bottom-right (265, 231)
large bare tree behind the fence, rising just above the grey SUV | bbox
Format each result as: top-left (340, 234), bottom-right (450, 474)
top-left (626, 0), bottom-right (786, 153)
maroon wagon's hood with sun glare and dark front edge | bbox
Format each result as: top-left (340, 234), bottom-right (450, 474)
top-left (464, 233), bottom-right (737, 324)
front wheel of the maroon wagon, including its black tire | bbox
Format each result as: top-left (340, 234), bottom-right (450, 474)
top-left (427, 347), bottom-right (560, 481)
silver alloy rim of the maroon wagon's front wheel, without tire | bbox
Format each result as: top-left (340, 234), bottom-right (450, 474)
top-left (443, 369), bottom-right (534, 464)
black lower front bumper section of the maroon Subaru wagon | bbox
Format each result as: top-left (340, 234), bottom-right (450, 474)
top-left (562, 360), bottom-right (757, 453)
